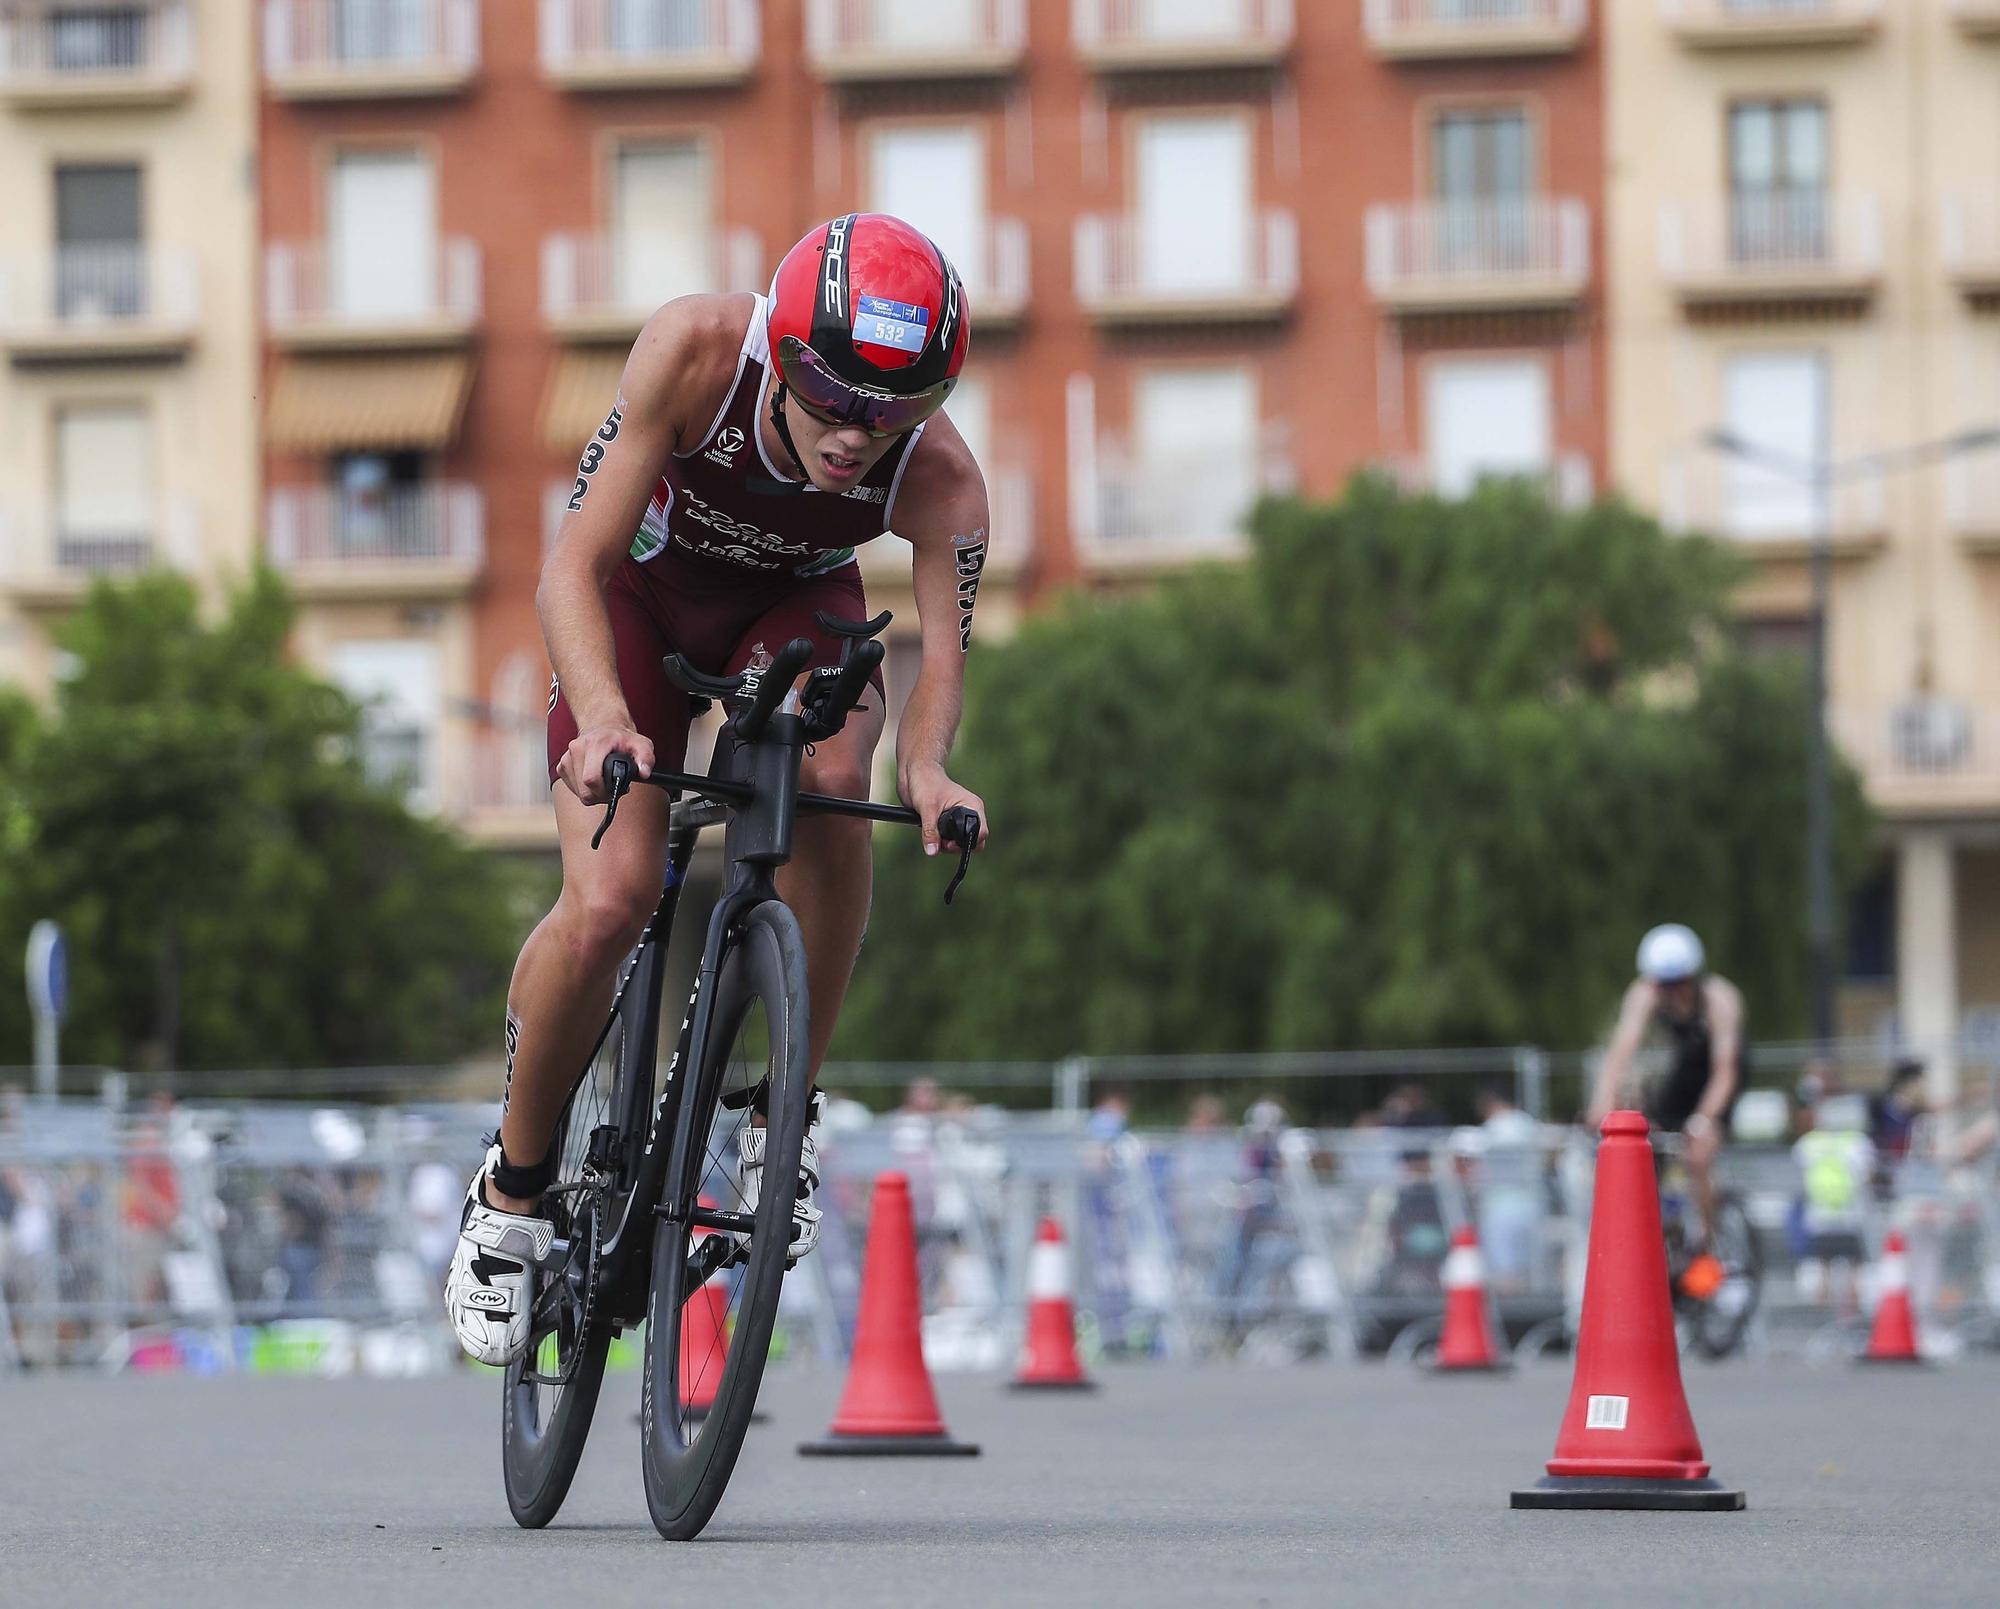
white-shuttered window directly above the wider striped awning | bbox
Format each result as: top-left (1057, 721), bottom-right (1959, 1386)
top-left (328, 150), bottom-right (438, 322)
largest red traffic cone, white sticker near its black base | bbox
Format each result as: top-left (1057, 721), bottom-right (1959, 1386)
top-left (1512, 1113), bottom-right (1744, 1509)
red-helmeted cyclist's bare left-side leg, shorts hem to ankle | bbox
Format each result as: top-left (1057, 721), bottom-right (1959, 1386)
top-left (488, 782), bottom-right (668, 1213)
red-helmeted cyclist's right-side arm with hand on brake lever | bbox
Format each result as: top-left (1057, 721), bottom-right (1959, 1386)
top-left (894, 414), bottom-right (988, 851)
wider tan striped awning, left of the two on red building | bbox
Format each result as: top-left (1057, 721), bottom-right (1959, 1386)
top-left (264, 352), bottom-right (472, 452)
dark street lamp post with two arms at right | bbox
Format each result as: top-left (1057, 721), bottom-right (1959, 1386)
top-left (1702, 428), bottom-right (2000, 1055)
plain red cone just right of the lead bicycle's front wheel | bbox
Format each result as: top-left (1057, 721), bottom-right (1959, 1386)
top-left (798, 1173), bottom-right (980, 1457)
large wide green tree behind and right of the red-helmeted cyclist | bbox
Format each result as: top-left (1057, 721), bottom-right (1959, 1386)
top-left (834, 478), bottom-right (1866, 1059)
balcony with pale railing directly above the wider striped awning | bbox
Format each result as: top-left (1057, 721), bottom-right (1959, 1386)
top-left (264, 238), bottom-right (480, 352)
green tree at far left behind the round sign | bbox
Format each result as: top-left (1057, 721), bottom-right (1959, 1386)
top-left (0, 572), bottom-right (520, 1067)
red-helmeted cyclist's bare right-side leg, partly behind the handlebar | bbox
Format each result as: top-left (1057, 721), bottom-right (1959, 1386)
top-left (780, 688), bottom-right (886, 1083)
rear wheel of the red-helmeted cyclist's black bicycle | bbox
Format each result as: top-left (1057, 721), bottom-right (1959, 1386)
top-left (500, 989), bottom-right (652, 1529)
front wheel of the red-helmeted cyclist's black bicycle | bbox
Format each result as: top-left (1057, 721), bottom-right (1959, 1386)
top-left (640, 901), bottom-right (810, 1541)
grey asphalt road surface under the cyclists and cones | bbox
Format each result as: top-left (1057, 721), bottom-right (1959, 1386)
top-left (0, 1359), bottom-right (2000, 1609)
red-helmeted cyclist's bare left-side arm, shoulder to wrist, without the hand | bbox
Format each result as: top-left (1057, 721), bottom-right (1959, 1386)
top-left (534, 296), bottom-right (730, 732)
